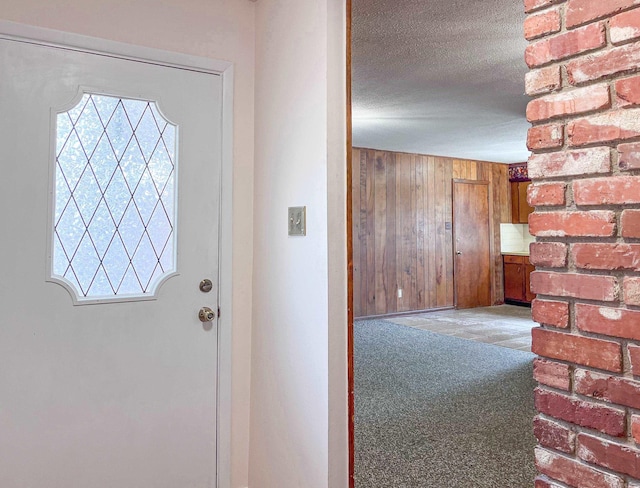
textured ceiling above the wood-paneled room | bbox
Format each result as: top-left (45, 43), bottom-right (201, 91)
top-left (352, 0), bottom-right (529, 163)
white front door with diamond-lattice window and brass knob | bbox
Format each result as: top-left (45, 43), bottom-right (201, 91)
top-left (0, 35), bottom-right (222, 488)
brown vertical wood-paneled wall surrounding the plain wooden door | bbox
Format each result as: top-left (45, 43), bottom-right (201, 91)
top-left (352, 148), bottom-right (510, 317)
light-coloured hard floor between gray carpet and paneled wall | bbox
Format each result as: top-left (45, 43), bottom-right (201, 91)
top-left (385, 305), bottom-right (536, 352)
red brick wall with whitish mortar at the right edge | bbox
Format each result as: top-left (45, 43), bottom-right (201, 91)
top-left (524, 0), bottom-right (640, 488)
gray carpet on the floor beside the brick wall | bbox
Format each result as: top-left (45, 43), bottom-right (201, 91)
top-left (354, 320), bottom-right (535, 488)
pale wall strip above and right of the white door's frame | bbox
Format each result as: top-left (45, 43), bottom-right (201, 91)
top-left (0, 0), bottom-right (255, 488)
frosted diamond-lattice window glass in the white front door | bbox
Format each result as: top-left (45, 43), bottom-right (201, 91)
top-left (52, 93), bottom-right (177, 300)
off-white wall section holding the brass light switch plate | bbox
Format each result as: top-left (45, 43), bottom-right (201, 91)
top-left (249, 0), bottom-right (347, 488)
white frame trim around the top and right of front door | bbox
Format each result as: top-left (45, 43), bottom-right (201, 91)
top-left (0, 20), bottom-right (233, 488)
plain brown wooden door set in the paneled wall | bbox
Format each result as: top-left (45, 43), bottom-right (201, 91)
top-left (453, 180), bottom-right (491, 308)
